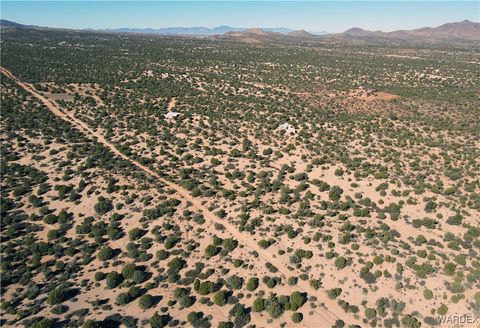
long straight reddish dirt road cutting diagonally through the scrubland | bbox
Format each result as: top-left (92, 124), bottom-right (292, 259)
top-left (0, 67), bottom-right (360, 327)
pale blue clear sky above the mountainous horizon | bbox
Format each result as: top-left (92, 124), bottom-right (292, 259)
top-left (1, 0), bottom-right (480, 32)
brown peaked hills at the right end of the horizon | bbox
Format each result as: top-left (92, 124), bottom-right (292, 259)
top-left (338, 20), bottom-right (480, 43)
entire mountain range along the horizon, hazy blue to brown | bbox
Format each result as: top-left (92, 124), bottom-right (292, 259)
top-left (0, 19), bottom-right (480, 44)
